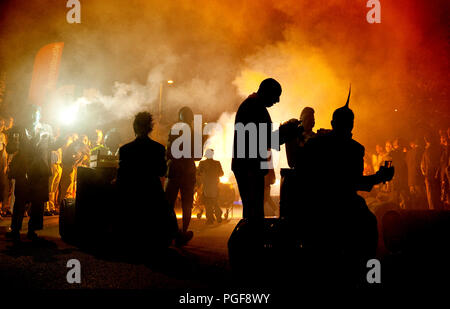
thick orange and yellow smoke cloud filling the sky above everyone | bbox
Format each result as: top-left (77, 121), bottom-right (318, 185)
top-left (0, 0), bottom-right (449, 146)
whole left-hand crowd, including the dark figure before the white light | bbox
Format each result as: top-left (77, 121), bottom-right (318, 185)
top-left (0, 105), bottom-right (128, 241)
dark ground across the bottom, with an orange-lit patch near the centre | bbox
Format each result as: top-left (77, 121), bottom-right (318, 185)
top-left (0, 207), bottom-right (450, 296)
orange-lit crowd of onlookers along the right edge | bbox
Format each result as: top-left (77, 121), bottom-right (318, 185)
top-left (364, 128), bottom-right (450, 210)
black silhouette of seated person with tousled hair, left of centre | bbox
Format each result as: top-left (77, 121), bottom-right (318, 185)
top-left (117, 112), bottom-right (178, 251)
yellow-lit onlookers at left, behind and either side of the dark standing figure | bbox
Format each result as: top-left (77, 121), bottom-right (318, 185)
top-left (0, 113), bottom-right (120, 221)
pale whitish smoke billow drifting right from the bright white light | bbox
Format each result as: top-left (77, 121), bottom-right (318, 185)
top-left (62, 48), bottom-right (241, 124)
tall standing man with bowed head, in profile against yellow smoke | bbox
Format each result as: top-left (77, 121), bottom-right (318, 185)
top-left (231, 78), bottom-right (298, 220)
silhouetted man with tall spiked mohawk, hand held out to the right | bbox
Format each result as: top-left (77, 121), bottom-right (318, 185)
top-left (298, 88), bottom-right (394, 283)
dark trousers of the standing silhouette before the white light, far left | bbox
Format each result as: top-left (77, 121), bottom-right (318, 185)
top-left (11, 179), bottom-right (45, 233)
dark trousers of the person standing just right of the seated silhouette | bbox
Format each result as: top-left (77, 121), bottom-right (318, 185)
top-left (165, 177), bottom-right (195, 232)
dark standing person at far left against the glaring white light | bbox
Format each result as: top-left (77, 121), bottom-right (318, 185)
top-left (6, 105), bottom-right (58, 241)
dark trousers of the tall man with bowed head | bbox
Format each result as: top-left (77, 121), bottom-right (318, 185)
top-left (234, 170), bottom-right (264, 221)
